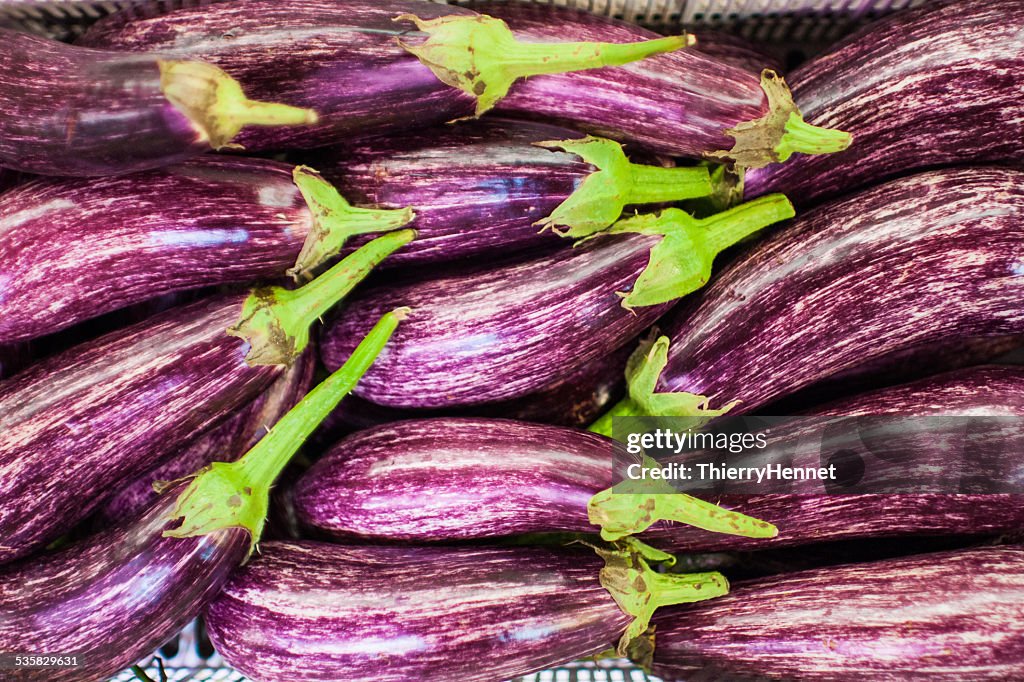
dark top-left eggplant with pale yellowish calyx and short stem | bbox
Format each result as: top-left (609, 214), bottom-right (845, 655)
top-left (0, 29), bottom-right (316, 176)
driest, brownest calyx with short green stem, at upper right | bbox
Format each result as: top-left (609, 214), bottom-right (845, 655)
top-left (707, 69), bottom-right (853, 168)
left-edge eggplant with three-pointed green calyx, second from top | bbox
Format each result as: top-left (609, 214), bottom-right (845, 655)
top-left (0, 158), bottom-right (413, 343)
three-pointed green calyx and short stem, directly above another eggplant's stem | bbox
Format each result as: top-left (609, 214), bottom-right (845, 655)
top-left (288, 166), bottom-right (416, 282)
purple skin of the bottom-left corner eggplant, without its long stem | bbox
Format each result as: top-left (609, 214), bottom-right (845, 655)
top-left (0, 485), bottom-right (249, 682)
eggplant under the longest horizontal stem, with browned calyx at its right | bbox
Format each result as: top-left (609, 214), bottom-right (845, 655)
top-left (486, 2), bottom-right (851, 168)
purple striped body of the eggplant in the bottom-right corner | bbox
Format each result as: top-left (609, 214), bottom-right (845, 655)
top-left (651, 546), bottom-right (1024, 682)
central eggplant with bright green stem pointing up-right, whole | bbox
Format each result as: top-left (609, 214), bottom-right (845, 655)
top-left (321, 196), bottom-right (793, 408)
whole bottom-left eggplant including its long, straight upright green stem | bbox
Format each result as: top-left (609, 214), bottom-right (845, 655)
top-left (0, 312), bottom-right (400, 682)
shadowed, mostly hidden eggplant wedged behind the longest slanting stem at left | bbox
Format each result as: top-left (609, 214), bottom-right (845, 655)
top-left (95, 347), bottom-right (315, 527)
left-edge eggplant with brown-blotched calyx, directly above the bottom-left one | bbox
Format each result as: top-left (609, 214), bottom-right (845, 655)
top-left (0, 230), bottom-right (413, 561)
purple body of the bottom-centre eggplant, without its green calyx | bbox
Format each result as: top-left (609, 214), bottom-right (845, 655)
top-left (207, 542), bottom-right (630, 682)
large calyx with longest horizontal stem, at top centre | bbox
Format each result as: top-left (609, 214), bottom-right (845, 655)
top-left (394, 14), bottom-right (695, 116)
